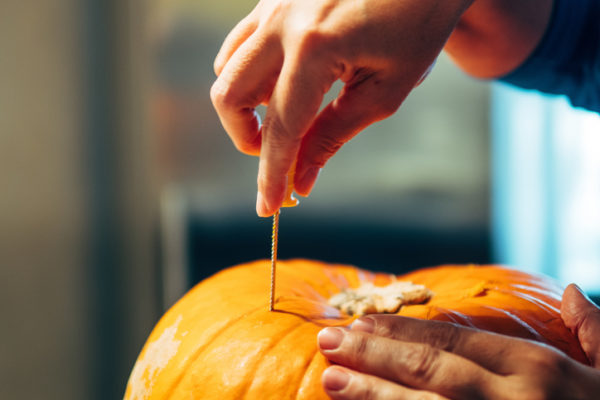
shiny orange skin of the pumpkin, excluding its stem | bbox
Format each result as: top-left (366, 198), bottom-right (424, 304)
top-left (125, 259), bottom-right (588, 400)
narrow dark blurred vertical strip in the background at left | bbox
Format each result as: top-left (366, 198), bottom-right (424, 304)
top-left (83, 0), bottom-right (125, 400)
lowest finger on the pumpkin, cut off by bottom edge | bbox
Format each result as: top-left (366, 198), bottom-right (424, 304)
top-left (322, 366), bottom-right (445, 400)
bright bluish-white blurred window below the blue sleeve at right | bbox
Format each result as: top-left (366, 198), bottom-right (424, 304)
top-left (492, 84), bottom-right (600, 293)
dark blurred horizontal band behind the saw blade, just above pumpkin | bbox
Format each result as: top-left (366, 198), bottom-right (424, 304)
top-left (187, 214), bottom-right (490, 287)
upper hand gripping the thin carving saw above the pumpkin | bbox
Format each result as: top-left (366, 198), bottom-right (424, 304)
top-left (211, 0), bottom-right (473, 216)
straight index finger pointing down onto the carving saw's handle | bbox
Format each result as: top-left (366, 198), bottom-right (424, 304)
top-left (256, 58), bottom-right (337, 217)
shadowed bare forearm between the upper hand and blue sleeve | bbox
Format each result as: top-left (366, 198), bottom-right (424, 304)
top-left (445, 0), bottom-right (554, 78)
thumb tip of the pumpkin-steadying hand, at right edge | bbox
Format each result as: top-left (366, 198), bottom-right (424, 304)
top-left (560, 284), bottom-right (600, 368)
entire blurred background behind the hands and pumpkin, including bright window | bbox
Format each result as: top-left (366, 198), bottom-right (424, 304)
top-left (0, 0), bottom-right (600, 400)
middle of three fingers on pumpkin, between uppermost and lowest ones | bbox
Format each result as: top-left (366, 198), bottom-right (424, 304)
top-left (318, 328), bottom-right (503, 398)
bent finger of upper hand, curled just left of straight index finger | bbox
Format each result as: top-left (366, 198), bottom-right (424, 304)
top-left (211, 31), bottom-right (283, 155)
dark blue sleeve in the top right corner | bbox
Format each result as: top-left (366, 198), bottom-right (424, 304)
top-left (500, 0), bottom-right (600, 112)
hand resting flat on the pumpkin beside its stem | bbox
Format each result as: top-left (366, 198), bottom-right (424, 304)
top-left (318, 285), bottom-right (600, 400)
